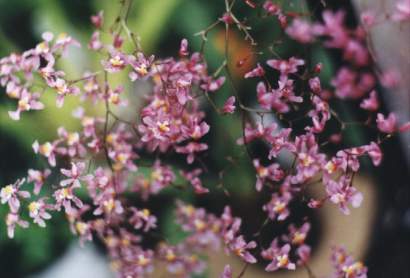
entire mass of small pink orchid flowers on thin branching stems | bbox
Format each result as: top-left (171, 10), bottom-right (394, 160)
top-left (0, 0), bottom-right (410, 278)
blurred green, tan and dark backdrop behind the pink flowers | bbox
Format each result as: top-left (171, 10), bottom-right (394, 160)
top-left (0, 0), bottom-right (410, 278)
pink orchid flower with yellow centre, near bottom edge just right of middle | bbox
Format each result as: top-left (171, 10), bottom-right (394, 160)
top-left (261, 239), bottom-right (296, 271)
